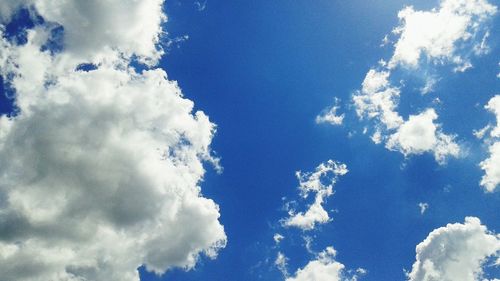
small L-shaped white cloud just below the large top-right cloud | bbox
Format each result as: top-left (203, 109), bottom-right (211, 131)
top-left (353, 69), bottom-right (460, 163)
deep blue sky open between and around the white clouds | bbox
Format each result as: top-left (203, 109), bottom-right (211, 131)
top-left (0, 0), bottom-right (500, 281)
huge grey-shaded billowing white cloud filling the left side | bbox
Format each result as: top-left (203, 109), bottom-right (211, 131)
top-left (0, 1), bottom-right (226, 281)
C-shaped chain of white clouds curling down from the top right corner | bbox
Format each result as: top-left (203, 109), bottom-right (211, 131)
top-left (353, 0), bottom-right (497, 164)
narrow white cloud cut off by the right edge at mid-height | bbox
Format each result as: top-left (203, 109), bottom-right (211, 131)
top-left (479, 95), bottom-right (500, 192)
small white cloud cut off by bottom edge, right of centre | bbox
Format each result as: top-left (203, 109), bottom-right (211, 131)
top-left (286, 247), bottom-right (366, 281)
